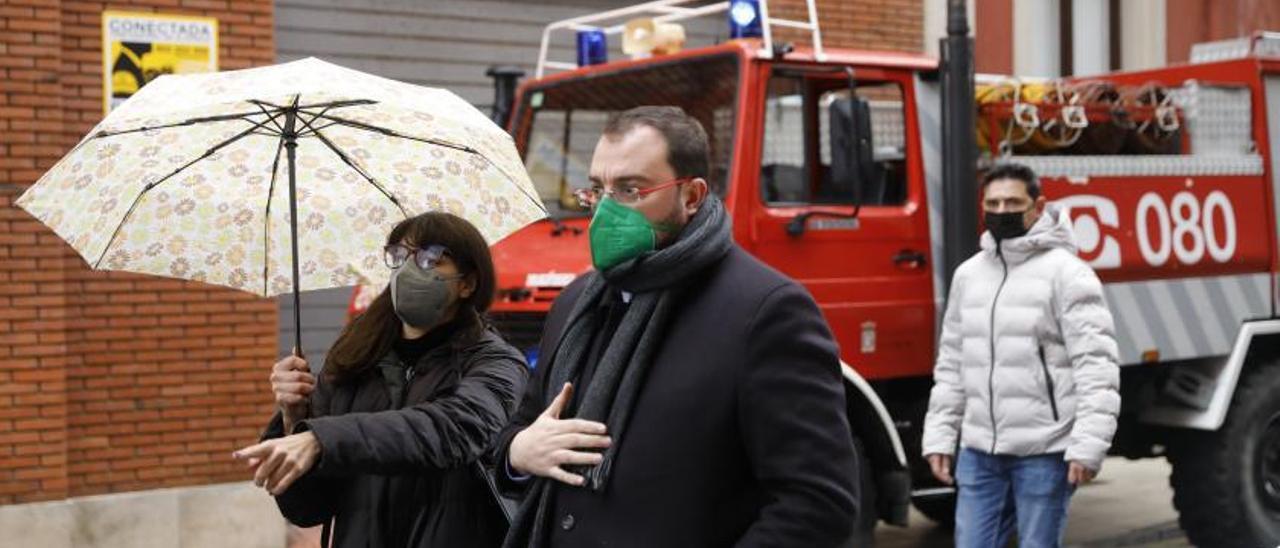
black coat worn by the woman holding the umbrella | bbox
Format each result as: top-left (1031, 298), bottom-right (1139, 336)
top-left (264, 332), bottom-right (529, 547)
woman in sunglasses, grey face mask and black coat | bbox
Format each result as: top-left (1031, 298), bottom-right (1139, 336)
top-left (234, 213), bottom-right (527, 547)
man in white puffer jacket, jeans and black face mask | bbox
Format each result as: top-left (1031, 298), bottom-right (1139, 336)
top-left (923, 164), bottom-right (1120, 548)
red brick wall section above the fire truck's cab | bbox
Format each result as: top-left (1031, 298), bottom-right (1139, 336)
top-left (769, 0), bottom-right (924, 52)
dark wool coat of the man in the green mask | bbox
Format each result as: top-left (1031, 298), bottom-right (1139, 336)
top-left (498, 246), bottom-right (858, 548)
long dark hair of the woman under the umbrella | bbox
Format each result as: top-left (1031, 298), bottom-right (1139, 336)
top-left (324, 211), bottom-right (497, 383)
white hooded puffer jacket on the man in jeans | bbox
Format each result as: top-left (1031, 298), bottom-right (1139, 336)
top-left (923, 205), bottom-right (1120, 470)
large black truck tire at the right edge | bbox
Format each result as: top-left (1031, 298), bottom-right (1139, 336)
top-left (1169, 361), bottom-right (1280, 547)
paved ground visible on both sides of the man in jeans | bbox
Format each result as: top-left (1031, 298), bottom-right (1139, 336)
top-left (876, 458), bottom-right (1190, 548)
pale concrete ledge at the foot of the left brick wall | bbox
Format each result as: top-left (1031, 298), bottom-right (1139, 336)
top-left (0, 483), bottom-right (285, 548)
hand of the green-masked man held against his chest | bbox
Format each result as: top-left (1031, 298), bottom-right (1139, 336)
top-left (508, 383), bottom-right (611, 485)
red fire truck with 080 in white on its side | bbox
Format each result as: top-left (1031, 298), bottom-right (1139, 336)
top-left (353, 0), bottom-right (1280, 545)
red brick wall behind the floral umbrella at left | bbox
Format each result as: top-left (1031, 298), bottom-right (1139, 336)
top-left (0, 0), bottom-right (275, 503)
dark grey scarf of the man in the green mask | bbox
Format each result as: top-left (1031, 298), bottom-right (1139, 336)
top-left (503, 195), bottom-right (733, 548)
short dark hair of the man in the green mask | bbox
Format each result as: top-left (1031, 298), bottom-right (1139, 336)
top-left (604, 106), bottom-right (712, 179)
